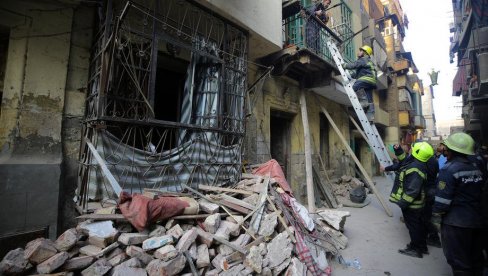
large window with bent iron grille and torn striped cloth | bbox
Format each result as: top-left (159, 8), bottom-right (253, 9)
top-left (79, 0), bottom-right (247, 209)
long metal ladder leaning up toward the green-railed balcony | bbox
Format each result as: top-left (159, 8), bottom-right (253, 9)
top-left (327, 40), bottom-right (392, 177)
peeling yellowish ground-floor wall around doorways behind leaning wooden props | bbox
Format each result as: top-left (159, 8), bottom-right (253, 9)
top-left (244, 72), bottom-right (353, 202)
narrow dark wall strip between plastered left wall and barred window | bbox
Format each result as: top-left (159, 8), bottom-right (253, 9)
top-left (59, 7), bottom-right (95, 232)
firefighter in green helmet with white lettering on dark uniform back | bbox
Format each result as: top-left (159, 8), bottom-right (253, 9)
top-left (432, 132), bottom-right (484, 276)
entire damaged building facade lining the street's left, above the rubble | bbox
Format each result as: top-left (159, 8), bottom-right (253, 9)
top-left (0, 0), bottom-right (425, 254)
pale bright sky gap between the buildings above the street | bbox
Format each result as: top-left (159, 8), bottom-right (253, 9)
top-left (400, 0), bottom-right (461, 123)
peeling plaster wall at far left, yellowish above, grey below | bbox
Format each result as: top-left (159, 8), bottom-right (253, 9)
top-left (0, 1), bottom-right (73, 237)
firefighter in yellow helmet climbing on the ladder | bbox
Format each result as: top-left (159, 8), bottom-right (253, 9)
top-left (342, 45), bottom-right (376, 119)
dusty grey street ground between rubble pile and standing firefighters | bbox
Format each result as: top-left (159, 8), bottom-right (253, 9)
top-left (331, 177), bottom-right (451, 276)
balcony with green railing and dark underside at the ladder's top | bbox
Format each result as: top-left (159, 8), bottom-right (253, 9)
top-left (259, 1), bottom-right (355, 88)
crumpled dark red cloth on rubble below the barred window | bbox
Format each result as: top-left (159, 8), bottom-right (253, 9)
top-left (119, 192), bottom-right (190, 231)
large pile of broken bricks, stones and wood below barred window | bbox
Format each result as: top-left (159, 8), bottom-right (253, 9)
top-left (0, 161), bottom-right (349, 276)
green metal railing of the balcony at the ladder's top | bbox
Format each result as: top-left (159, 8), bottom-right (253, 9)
top-left (283, 0), bottom-right (355, 63)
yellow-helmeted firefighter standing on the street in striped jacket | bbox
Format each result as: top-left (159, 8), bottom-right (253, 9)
top-left (390, 142), bottom-right (434, 258)
